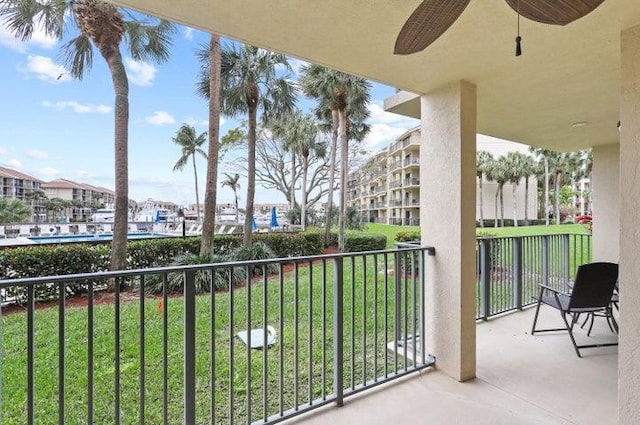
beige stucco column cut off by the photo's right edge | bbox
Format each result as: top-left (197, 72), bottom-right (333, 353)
top-left (618, 26), bottom-right (640, 425)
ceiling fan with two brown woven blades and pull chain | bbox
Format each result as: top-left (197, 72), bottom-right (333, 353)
top-left (393, 0), bottom-right (604, 56)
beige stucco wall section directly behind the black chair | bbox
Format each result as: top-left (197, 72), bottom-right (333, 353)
top-left (592, 143), bottom-right (620, 263)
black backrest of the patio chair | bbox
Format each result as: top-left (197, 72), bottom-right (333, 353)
top-left (569, 262), bottom-right (618, 309)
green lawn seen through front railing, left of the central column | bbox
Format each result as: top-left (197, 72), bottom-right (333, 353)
top-left (2, 257), bottom-right (417, 424)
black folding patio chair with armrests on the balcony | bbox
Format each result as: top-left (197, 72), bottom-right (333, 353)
top-left (531, 262), bottom-right (618, 357)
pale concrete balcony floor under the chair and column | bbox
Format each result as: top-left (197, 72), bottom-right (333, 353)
top-left (287, 307), bottom-right (618, 425)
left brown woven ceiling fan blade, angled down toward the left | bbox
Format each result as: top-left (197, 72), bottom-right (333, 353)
top-left (393, 0), bottom-right (471, 55)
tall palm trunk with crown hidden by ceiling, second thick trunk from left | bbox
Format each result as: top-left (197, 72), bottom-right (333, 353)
top-left (200, 34), bottom-right (220, 258)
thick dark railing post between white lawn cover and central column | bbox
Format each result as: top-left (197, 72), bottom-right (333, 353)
top-left (333, 257), bottom-right (344, 406)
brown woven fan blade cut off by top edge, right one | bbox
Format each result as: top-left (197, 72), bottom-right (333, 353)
top-left (505, 0), bottom-right (604, 25)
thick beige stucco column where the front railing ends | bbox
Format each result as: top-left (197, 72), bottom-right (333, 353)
top-left (420, 81), bottom-right (476, 381)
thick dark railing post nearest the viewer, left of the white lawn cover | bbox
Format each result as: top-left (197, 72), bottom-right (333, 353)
top-left (184, 270), bottom-right (196, 424)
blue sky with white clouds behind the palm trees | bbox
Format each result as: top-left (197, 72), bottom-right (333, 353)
top-left (0, 13), bottom-right (418, 205)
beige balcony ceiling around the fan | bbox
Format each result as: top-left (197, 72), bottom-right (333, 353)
top-left (107, 0), bottom-right (640, 150)
